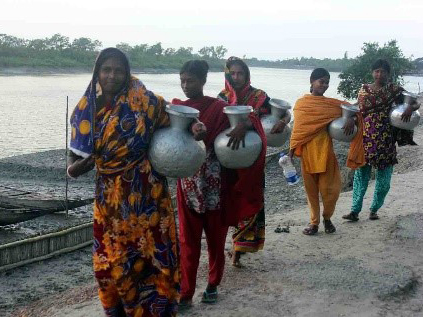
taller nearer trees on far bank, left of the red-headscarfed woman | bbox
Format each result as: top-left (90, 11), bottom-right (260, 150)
top-left (0, 34), bottom-right (227, 71)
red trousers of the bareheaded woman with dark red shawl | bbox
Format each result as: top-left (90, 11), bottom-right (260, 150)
top-left (178, 200), bottom-right (228, 299)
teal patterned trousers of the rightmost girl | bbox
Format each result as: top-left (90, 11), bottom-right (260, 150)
top-left (351, 165), bottom-right (394, 214)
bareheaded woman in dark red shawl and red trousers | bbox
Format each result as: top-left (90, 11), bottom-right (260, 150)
top-left (172, 60), bottom-right (265, 307)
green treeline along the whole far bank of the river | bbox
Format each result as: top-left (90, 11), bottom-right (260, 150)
top-left (0, 34), bottom-right (423, 74)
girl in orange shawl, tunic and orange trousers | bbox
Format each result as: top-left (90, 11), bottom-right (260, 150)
top-left (290, 68), bottom-right (359, 235)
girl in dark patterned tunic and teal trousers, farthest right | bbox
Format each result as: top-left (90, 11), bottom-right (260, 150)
top-left (342, 59), bottom-right (418, 221)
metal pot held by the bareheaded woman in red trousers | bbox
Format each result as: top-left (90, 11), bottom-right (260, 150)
top-left (214, 106), bottom-right (262, 168)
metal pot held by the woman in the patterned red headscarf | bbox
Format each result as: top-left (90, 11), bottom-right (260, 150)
top-left (260, 98), bottom-right (291, 147)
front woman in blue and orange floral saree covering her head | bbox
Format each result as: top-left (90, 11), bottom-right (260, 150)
top-left (68, 48), bottom-right (205, 317)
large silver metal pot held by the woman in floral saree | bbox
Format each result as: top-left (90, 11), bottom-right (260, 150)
top-left (148, 105), bottom-right (206, 178)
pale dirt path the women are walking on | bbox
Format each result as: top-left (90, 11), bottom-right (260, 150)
top-left (9, 163), bottom-right (423, 317)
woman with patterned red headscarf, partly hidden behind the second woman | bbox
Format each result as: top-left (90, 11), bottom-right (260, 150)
top-left (218, 56), bottom-right (291, 267)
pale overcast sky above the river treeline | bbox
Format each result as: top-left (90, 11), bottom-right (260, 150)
top-left (0, 0), bottom-right (423, 60)
